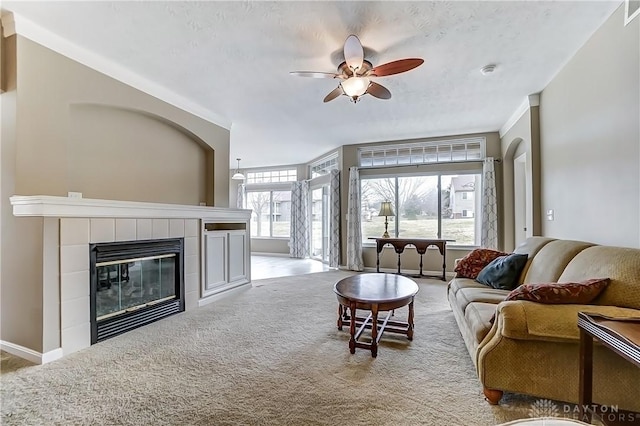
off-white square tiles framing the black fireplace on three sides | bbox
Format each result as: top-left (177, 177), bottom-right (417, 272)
top-left (60, 218), bottom-right (201, 355)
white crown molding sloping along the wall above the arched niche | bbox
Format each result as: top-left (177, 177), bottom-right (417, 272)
top-left (2, 12), bottom-right (231, 130)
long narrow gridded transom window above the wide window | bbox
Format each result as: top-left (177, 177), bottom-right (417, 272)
top-left (358, 137), bottom-right (486, 167)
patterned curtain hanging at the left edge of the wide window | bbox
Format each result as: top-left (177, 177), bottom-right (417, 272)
top-left (347, 167), bottom-right (364, 271)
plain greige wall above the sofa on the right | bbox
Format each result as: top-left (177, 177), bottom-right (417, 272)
top-left (540, 6), bottom-right (640, 247)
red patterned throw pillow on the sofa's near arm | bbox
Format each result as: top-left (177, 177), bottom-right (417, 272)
top-left (504, 278), bottom-right (611, 305)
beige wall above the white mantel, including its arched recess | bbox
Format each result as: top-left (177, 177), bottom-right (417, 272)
top-left (16, 36), bottom-right (229, 207)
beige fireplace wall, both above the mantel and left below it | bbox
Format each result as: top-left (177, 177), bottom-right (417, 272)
top-left (0, 36), bottom-right (229, 352)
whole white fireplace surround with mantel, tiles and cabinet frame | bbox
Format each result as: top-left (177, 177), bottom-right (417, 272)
top-left (11, 196), bottom-right (251, 363)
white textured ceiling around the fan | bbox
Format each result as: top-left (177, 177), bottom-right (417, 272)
top-left (3, 1), bottom-right (622, 167)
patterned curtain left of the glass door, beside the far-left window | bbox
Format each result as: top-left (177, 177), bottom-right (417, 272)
top-left (289, 181), bottom-right (309, 259)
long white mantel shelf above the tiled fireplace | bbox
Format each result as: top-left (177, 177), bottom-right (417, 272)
top-left (10, 195), bottom-right (251, 218)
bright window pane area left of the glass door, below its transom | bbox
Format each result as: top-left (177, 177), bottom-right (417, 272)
top-left (247, 191), bottom-right (291, 238)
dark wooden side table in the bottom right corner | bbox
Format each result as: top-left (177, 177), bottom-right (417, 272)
top-left (578, 312), bottom-right (640, 424)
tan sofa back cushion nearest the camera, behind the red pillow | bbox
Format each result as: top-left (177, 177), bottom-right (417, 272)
top-left (559, 246), bottom-right (640, 309)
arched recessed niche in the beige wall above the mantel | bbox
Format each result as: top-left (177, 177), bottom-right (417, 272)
top-left (67, 103), bottom-right (215, 205)
